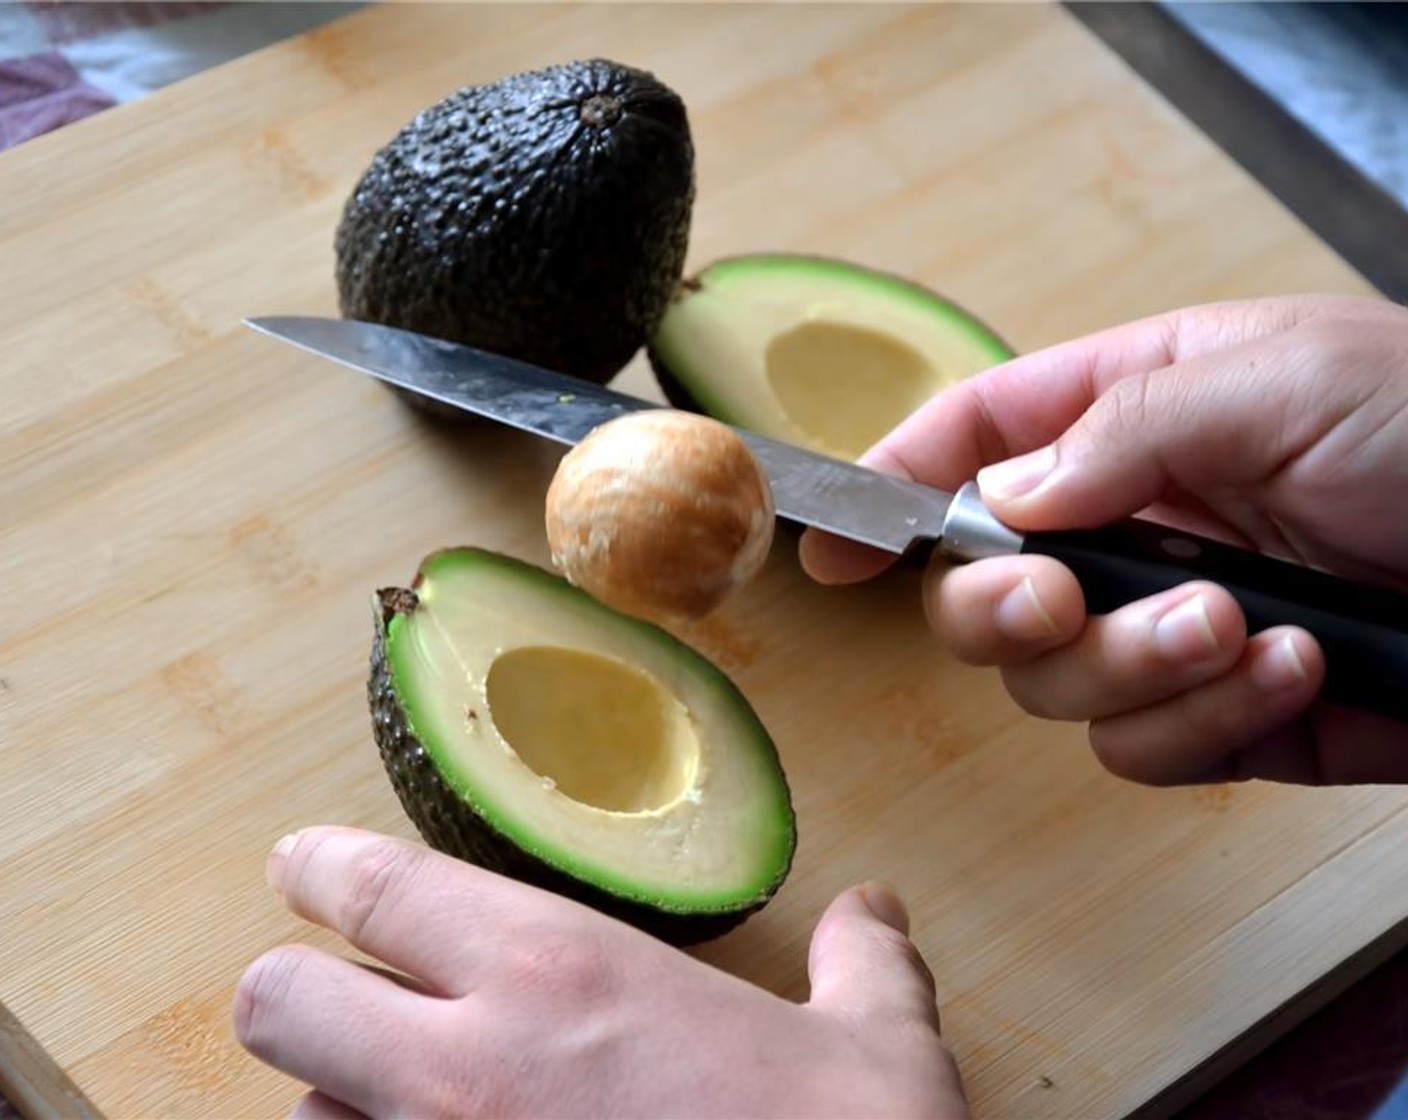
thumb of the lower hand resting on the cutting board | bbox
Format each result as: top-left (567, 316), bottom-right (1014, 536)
top-left (807, 883), bottom-right (939, 1031)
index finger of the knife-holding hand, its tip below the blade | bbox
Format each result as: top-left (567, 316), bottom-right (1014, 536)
top-left (800, 299), bottom-right (1309, 583)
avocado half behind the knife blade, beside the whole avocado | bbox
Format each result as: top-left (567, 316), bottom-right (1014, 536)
top-left (648, 254), bottom-right (1014, 459)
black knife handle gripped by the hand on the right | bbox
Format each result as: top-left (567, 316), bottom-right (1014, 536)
top-left (1021, 521), bottom-right (1408, 723)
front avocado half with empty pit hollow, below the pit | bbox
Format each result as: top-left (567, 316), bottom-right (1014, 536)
top-left (369, 548), bottom-right (797, 945)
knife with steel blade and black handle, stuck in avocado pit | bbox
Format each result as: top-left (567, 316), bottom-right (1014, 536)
top-left (245, 316), bottom-right (1408, 723)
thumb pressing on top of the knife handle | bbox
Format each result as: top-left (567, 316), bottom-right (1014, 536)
top-left (977, 332), bottom-right (1329, 530)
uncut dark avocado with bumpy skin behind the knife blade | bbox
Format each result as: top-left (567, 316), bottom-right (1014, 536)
top-left (335, 59), bottom-right (694, 383)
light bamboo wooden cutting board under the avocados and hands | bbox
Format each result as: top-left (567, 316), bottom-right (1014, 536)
top-left (0, 4), bottom-right (1408, 1117)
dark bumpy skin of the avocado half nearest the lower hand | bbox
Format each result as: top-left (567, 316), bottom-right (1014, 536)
top-left (367, 594), bottom-right (791, 948)
